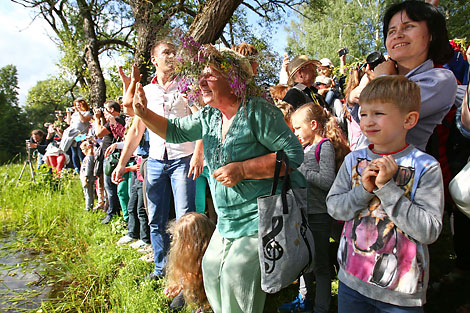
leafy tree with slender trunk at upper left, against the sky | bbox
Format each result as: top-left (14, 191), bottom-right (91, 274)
top-left (12, 0), bottom-right (132, 106)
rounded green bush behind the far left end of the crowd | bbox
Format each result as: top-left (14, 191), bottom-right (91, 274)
top-left (25, 77), bottom-right (78, 129)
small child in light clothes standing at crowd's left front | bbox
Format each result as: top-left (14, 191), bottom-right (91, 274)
top-left (80, 140), bottom-right (95, 211)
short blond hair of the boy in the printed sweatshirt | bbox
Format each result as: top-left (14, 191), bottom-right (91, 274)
top-left (359, 75), bottom-right (421, 113)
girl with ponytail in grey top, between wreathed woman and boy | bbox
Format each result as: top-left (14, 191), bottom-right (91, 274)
top-left (278, 103), bottom-right (349, 313)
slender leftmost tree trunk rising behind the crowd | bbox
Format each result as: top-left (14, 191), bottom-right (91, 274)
top-left (77, 0), bottom-right (106, 107)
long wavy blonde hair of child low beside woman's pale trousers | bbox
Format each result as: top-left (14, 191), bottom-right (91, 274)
top-left (166, 212), bottom-right (215, 308)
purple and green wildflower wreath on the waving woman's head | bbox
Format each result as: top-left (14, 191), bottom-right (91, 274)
top-left (175, 35), bottom-right (266, 102)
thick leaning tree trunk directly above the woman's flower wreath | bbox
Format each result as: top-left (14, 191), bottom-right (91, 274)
top-left (188, 0), bottom-right (243, 44)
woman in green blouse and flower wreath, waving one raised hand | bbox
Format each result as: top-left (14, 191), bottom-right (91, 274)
top-left (134, 45), bottom-right (305, 313)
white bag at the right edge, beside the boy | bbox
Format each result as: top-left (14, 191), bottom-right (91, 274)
top-left (449, 162), bottom-right (470, 218)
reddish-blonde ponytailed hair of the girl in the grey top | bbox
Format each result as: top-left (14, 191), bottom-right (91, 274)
top-left (294, 102), bottom-right (351, 172)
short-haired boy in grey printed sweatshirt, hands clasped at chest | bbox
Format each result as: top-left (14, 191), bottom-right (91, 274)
top-left (327, 75), bottom-right (444, 313)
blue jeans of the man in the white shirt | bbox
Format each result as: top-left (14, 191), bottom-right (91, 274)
top-left (146, 156), bottom-right (196, 275)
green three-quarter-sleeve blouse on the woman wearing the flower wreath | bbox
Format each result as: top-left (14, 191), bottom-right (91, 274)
top-left (166, 98), bottom-right (306, 238)
